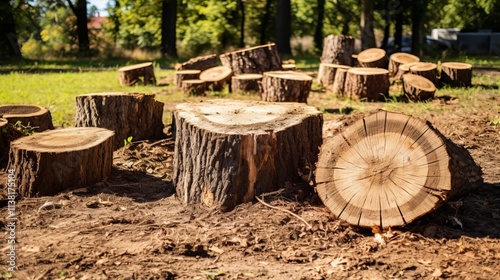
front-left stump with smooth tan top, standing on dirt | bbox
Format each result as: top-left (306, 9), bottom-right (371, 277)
top-left (7, 127), bottom-right (114, 197)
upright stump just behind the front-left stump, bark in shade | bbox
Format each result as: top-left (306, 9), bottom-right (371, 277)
top-left (75, 92), bottom-right (163, 150)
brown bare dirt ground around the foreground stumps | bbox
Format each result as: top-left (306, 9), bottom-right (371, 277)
top-left (0, 69), bottom-right (500, 279)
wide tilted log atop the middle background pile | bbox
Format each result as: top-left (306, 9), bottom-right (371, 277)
top-left (220, 43), bottom-right (283, 75)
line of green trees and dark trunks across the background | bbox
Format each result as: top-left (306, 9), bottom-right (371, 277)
top-left (0, 0), bottom-right (500, 58)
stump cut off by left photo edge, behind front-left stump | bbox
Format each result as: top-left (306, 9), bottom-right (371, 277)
top-left (0, 104), bottom-right (54, 132)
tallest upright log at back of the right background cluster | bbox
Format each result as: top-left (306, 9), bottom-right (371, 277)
top-left (321, 35), bottom-right (354, 66)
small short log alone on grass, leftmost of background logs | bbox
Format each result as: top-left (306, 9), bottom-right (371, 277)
top-left (118, 62), bottom-right (156, 86)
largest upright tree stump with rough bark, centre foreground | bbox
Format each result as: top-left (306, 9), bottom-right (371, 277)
top-left (173, 99), bottom-right (323, 210)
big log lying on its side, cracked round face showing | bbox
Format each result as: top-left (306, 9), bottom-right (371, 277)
top-left (316, 111), bottom-right (483, 228)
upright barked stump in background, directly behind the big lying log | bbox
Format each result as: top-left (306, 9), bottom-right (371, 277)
top-left (344, 67), bottom-right (390, 101)
